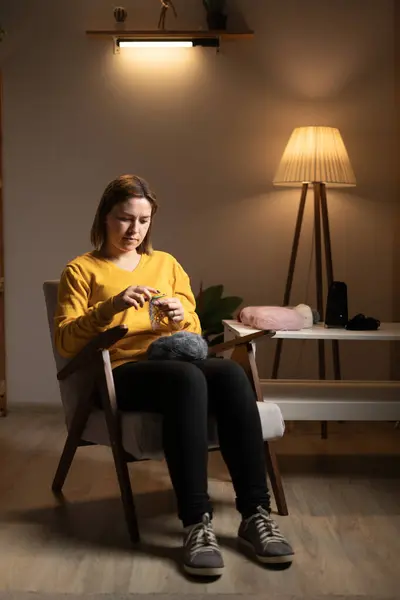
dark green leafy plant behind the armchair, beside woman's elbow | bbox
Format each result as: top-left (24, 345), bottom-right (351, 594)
top-left (196, 284), bottom-right (243, 346)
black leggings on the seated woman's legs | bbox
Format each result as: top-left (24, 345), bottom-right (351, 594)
top-left (114, 358), bottom-right (270, 527)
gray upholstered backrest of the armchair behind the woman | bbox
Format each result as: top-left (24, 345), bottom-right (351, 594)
top-left (43, 280), bottom-right (94, 426)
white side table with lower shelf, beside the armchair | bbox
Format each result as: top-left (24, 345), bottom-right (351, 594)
top-left (224, 320), bottom-right (400, 421)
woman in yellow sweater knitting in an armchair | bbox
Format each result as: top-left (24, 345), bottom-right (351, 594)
top-left (55, 175), bottom-right (293, 576)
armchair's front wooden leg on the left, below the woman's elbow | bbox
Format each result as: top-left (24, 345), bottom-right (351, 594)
top-left (99, 351), bottom-right (140, 544)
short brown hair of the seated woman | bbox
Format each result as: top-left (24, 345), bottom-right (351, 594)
top-left (90, 175), bottom-right (158, 254)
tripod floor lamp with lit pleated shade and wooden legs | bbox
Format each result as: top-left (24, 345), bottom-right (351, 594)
top-left (272, 127), bottom-right (356, 438)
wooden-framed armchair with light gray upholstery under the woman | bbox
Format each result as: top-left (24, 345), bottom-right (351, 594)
top-left (43, 281), bottom-right (288, 542)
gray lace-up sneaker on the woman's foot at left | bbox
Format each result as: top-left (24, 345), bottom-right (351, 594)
top-left (183, 514), bottom-right (224, 577)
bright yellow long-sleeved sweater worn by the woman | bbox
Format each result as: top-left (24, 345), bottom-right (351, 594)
top-left (55, 251), bottom-right (201, 368)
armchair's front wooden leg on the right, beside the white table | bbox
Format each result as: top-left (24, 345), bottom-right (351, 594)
top-left (231, 343), bottom-right (289, 515)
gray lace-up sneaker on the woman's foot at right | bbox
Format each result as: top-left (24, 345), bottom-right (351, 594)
top-left (238, 506), bottom-right (294, 564)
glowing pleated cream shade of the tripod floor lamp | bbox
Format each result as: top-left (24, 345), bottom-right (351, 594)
top-left (273, 127), bottom-right (356, 187)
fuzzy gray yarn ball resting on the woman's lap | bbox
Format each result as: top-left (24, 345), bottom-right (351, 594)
top-left (147, 331), bottom-right (208, 362)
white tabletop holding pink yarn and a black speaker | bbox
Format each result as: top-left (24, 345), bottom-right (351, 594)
top-left (224, 320), bottom-right (400, 341)
